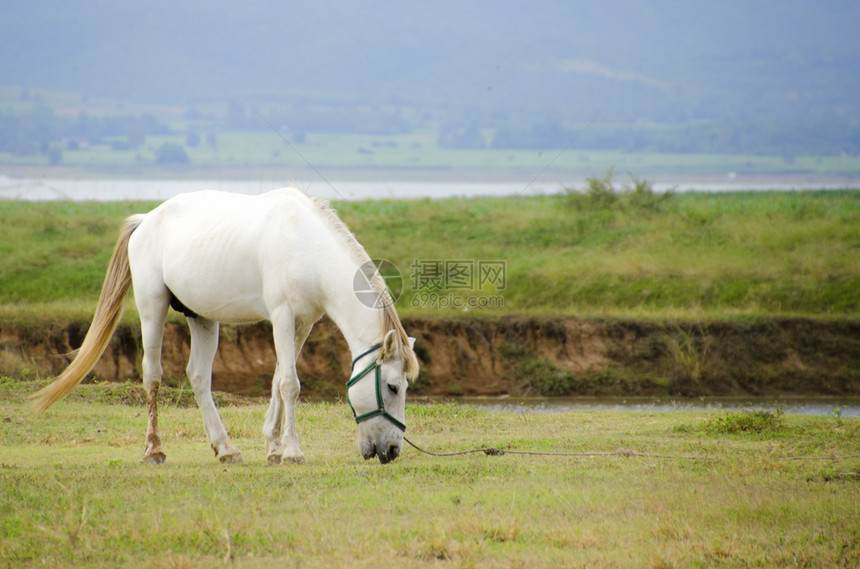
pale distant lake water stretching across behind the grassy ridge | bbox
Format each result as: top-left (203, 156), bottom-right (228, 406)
top-left (0, 176), bottom-right (846, 201)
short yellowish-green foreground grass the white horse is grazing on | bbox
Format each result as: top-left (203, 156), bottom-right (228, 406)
top-left (0, 379), bottom-right (860, 568)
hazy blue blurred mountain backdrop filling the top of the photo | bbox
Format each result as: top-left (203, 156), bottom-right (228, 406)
top-left (0, 0), bottom-right (860, 137)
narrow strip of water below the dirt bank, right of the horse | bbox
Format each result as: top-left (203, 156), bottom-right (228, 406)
top-left (456, 397), bottom-right (860, 417)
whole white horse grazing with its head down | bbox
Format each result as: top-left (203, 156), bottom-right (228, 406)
top-left (33, 188), bottom-right (418, 464)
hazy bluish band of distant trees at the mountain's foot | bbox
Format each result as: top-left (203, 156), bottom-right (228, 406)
top-left (0, 103), bottom-right (860, 160)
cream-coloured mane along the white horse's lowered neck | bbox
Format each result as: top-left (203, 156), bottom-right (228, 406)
top-left (308, 196), bottom-right (418, 381)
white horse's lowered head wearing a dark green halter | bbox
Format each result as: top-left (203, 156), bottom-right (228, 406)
top-left (346, 330), bottom-right (418, 464)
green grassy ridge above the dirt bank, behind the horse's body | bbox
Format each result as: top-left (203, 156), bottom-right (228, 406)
top-left (0, 186), bottom-right (860, 317)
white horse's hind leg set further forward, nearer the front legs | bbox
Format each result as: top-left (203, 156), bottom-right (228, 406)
top-left (186, 316), bottom-right (242, 462)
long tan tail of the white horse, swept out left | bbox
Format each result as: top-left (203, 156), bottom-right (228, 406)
top-left (30, 215), bottom-right (144, 413)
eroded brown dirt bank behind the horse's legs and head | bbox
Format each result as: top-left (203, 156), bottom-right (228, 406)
top-left (0, 318), bottom-right (860, 397)
